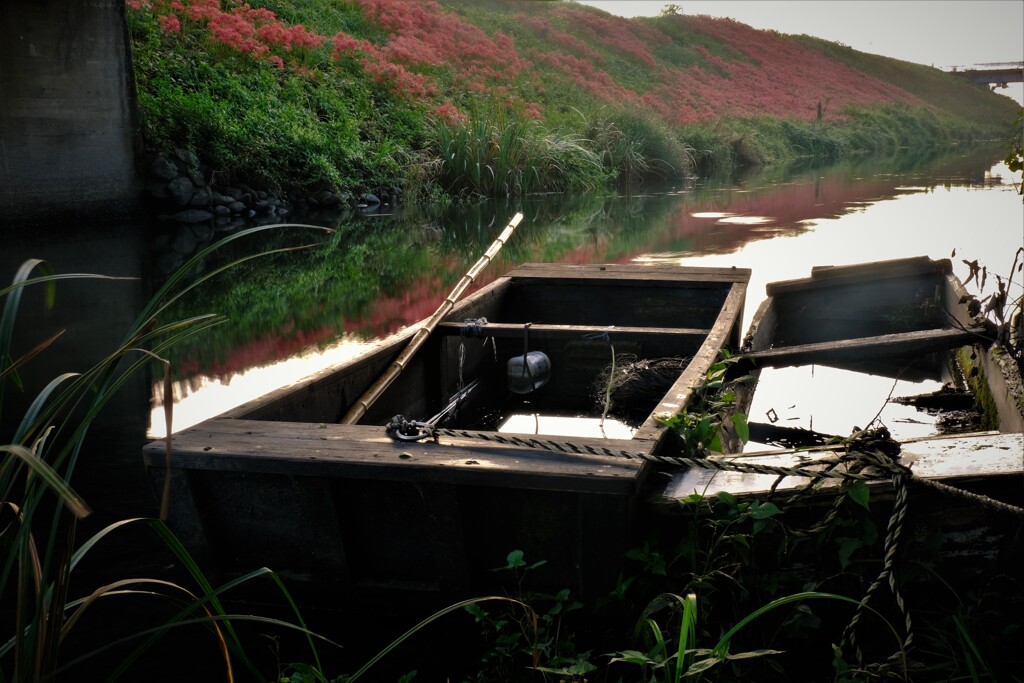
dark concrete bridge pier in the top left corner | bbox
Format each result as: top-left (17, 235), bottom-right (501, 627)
top-left (0, 0), bottom-right (139, 224)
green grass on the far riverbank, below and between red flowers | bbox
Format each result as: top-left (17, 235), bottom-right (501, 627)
top-left (128, 0), bottom-right (1015, 201)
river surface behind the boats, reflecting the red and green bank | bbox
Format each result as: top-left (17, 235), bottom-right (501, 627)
top-left (148, 146), bottom-right (1024, 438)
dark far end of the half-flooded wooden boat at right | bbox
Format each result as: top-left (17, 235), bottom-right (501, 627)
top-left (742, 257), bottom-right (1024, 433)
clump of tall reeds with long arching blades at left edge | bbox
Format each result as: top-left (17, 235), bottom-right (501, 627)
top-left (0, 226), bottom-right (333, 683)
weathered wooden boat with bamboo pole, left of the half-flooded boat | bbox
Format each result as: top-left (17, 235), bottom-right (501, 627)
top-left (144, 264), bottom-right (750, 605)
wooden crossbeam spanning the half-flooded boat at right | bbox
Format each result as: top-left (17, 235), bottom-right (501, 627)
top-left (743, 326), bottom-right (984, 368)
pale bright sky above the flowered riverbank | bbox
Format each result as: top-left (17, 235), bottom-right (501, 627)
top-left (578, 0), bottom-right (1024, 102)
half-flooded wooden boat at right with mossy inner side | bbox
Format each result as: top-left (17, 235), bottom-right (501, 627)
top-left (660, 257), bottom-right (1024, 566)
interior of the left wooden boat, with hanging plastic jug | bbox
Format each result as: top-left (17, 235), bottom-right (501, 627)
top-left (234, 264), bottom-right (750, 446)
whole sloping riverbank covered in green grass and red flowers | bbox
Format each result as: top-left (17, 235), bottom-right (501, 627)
top-left (126, 0), bottom-right (1018, 210)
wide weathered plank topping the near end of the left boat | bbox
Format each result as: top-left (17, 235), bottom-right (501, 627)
top-left (143, 419), bottom-right (646, 495)
